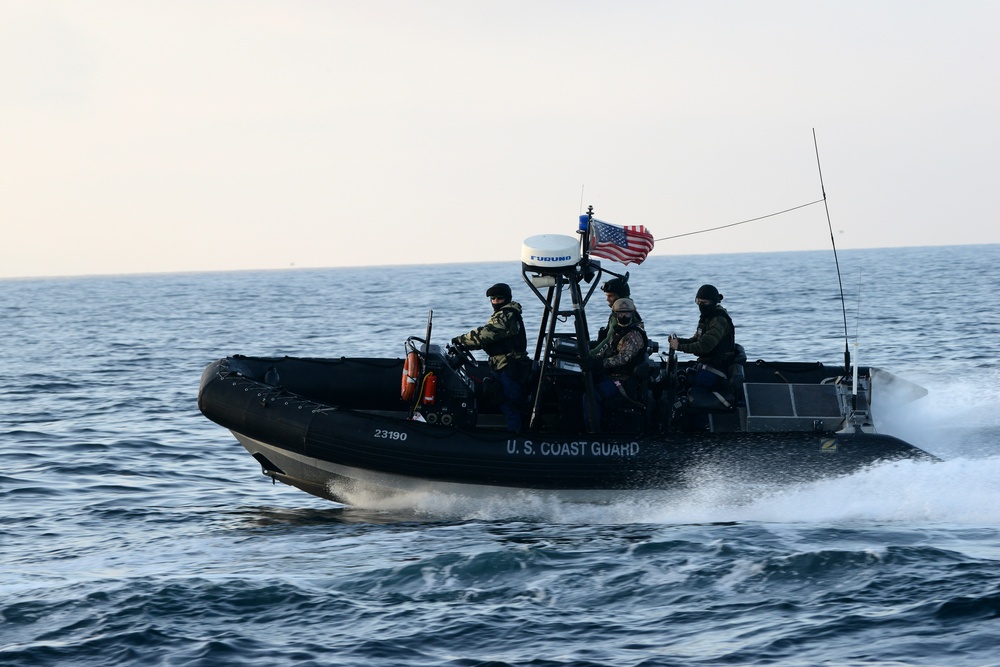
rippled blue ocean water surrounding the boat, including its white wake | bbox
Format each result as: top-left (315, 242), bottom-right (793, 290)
top-left (0, 245), bottom-right (1000, 667)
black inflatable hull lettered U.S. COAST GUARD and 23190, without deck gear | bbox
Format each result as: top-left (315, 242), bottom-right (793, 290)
top-left (198, 358), bottom-right (934, 503)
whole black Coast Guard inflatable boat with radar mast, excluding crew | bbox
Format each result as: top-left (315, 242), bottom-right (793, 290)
top-left (198, 223), bottom-right (934, 503)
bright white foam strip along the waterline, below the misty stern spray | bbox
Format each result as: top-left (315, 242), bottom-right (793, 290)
top-left (326, 456), bottom-right (1000, 526)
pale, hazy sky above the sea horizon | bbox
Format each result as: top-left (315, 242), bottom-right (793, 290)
top-left (0, 0), bottom-right (1000, 278)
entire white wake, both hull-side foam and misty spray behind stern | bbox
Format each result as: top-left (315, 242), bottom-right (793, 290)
top-left (322, 370), bottom-right (1000, 526)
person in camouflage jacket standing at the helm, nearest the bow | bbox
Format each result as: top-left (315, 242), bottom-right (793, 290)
top-left (451, 283), bottom-right (529, 433)
